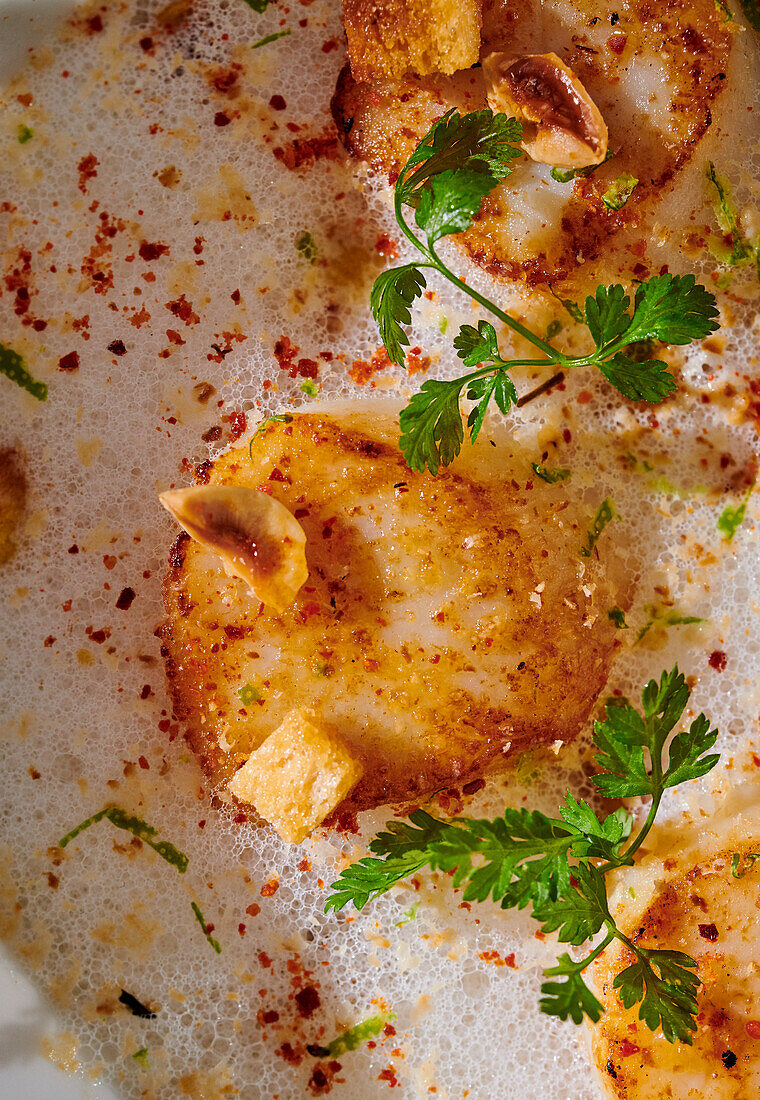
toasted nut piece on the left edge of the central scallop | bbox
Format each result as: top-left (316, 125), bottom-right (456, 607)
top-left (158, 485), bottom-right (309, 612)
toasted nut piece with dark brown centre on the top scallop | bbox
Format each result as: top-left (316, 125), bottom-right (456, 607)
top-left (483, 53), bottom-right (607, 168)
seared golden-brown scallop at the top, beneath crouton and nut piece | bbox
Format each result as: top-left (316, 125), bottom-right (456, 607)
top-left (332, 0), bottom-right (733, 286)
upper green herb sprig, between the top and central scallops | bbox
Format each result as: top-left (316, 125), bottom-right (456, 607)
top-left (371, 109), bottom-right (718, 474)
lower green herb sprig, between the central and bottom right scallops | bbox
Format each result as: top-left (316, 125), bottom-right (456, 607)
top-left (324, 666), bottom-right (718, 1043)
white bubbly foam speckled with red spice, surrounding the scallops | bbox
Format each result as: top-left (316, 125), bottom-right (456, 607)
top-left (0, 0), bottom-right (760, 1100)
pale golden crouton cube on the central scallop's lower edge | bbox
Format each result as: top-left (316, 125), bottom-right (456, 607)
top-left (229, 710), bottom-right (363, 844)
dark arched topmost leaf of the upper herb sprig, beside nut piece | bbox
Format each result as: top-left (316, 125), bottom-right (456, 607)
top-left (396, 108), bottom-right (522, 207)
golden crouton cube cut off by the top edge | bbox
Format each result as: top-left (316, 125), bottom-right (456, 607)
top-left (343, 0), bottom-right (483, 80)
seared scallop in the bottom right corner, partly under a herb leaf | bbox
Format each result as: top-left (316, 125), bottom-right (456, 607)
top-left (592, 783), bottom-right (760, 1100)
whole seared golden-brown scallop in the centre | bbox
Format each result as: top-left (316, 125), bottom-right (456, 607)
top-left (162, 410), bottom-right (630, 809)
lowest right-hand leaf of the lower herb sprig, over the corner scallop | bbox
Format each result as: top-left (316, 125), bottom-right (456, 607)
top-left (613, 948), bottom-right (700, 1044)
